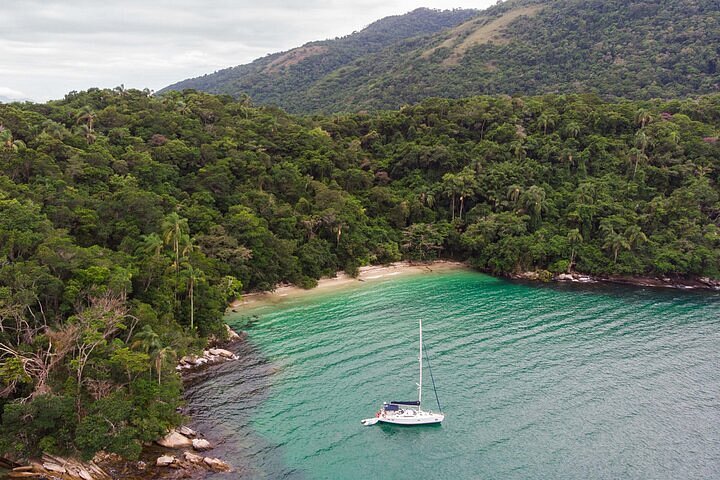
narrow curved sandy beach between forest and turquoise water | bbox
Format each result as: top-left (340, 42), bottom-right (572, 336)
top-left (230, 260), bottom-right (468, 310)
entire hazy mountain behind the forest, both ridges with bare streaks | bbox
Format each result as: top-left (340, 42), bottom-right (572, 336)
top-left (164, 0), bottom-right (720, 112)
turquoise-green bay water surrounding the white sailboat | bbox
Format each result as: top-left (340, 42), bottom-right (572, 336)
top-left (189, 271), bottom-right (720, 479)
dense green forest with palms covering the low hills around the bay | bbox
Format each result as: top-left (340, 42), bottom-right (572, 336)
top-left (0, 88), bottom-right (720, 458)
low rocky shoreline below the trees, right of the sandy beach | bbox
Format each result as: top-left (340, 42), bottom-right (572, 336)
top-left (508, 270), bottom-right (720, 291)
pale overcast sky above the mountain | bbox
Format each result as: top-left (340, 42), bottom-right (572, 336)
top-left (0, 0), bottom-right (495, 101)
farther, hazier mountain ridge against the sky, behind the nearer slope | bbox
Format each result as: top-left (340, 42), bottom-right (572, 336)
top-left (162, 8), bottom-right (478, 109)
